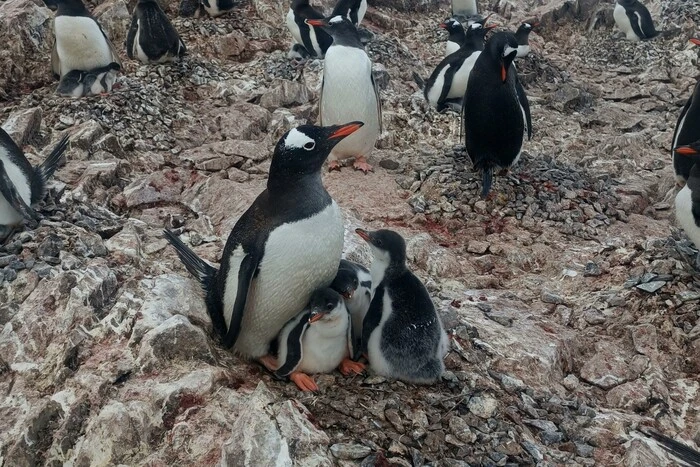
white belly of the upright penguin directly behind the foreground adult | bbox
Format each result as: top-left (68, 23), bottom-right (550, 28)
top-left (321, 46), bottom-right (379, 160)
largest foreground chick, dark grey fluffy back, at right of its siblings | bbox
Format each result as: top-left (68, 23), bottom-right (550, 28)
top-left (355, 229), bottom-right (448, 384)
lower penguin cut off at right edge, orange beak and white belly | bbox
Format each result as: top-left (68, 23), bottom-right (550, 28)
top-left (675, 141), bottom-right (700, 250)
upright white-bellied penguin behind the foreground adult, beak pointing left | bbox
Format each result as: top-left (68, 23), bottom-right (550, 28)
top-left (306, 16), bottom-right (382, 173)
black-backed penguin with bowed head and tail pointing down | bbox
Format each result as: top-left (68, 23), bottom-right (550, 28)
top-left (462, 32), bottom-right (532, 197)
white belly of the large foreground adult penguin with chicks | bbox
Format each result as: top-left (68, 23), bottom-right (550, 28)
top-left (232, 201), bottom-right (343, 358)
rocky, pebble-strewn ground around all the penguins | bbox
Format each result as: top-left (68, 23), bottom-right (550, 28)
top-left (0, 0), bottom-right (700, 466)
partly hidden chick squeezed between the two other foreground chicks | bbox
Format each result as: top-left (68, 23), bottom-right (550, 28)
top-left (331, 259), bottom-right (372, 358)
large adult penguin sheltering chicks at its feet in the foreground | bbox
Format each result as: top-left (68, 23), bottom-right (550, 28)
top-left (165, 122), bottom-right (363, 358)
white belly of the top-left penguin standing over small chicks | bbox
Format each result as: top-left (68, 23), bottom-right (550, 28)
top-left (54, 16), bottom-right (112, 76)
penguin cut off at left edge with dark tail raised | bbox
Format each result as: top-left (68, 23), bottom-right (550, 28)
top-left (0, 132), bottom-right (68, 240)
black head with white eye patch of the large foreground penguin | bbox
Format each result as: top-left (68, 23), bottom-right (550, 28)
top-left (268, 122), bottom-right (364, 181)
